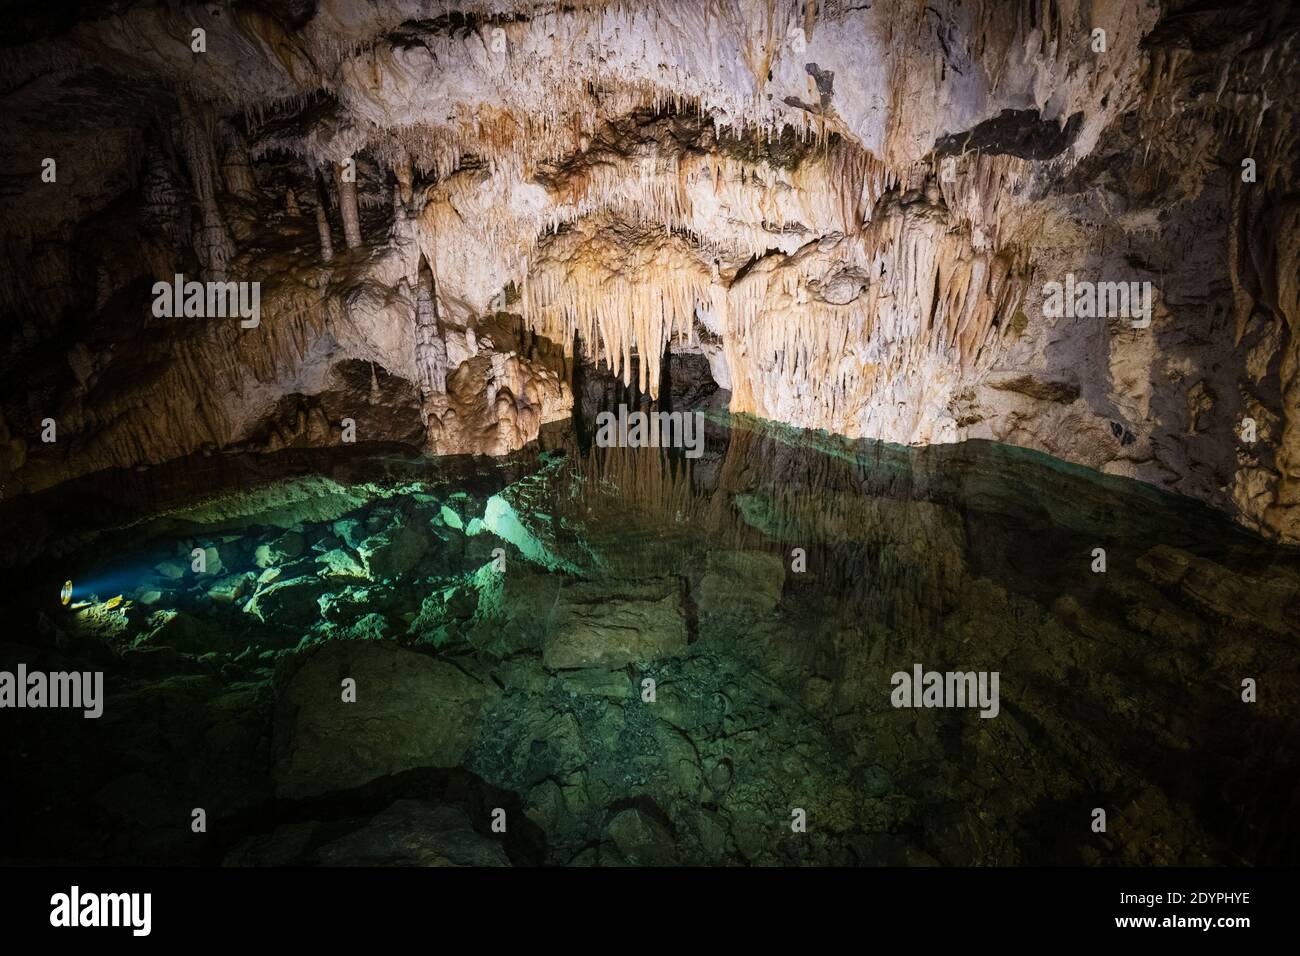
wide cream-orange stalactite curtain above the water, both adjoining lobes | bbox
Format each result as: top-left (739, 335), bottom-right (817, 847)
top-left (512, 170), bottom-right (1026, 423)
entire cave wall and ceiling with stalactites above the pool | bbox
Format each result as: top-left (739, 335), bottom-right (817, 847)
top-left (0, 0), bottom-right (1300, 541)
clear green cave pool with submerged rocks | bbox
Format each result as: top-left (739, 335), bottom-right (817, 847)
top-left (0, 412), bottom-right (1300, 865)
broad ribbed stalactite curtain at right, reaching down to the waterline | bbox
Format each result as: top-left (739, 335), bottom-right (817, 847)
top-left (714, 203), bottom-right (1024, 434)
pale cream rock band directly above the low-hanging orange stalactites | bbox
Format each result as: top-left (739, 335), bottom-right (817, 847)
top-left (416, 123), bottom-right (898, 321)
